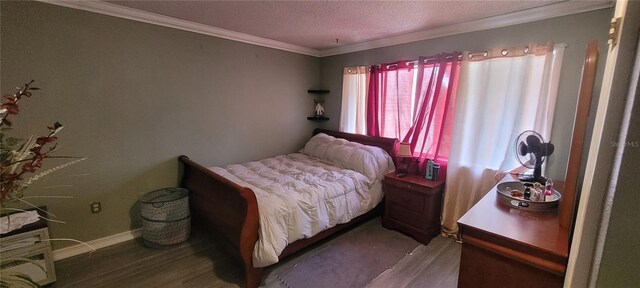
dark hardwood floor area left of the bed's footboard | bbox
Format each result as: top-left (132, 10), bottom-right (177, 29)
top-left (55, 229), bottom-right (242, 288)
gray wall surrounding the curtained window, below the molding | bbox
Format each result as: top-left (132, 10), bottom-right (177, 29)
top-left (320, 9), bottom-right (613, 179)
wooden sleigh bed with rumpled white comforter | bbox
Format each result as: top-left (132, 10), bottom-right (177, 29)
top-left (179, 129), bottom-right (397, 287)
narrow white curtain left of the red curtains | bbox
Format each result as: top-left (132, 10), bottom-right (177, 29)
top-left (340, 66), bottom-right (369, 134)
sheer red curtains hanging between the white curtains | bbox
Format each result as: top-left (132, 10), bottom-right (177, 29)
top-left (367, 52), bottom-right (460, 176)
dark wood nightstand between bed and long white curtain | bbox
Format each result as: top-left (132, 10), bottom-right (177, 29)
top-left (382, 172), bottom-right (445, 245)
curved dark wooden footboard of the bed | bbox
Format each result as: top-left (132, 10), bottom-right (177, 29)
top-left (179, 155), bottom-right (262, 287)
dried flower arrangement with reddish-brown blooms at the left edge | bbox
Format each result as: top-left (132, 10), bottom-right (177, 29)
top-left (0, 80), bottom-right (85, 209)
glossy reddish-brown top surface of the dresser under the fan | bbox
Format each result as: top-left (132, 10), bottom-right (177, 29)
top-left (458, 175), bottom-right (569, 258)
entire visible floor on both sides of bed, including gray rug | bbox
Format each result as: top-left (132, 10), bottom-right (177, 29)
top-left (53, 218), bottom-right (460, 288)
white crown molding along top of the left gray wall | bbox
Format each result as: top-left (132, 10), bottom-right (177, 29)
top-left (36, 0), bottom-right (320, 57)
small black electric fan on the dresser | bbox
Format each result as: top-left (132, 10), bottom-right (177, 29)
top-left (515, 130), bottom-right (554, 184)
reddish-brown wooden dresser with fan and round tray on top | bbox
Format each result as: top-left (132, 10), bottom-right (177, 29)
top-left (458, 175), bottom-right (569, 288)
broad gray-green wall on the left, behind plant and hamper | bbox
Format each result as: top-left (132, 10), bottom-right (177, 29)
top-left (0, 1), bottom-right (320, 248)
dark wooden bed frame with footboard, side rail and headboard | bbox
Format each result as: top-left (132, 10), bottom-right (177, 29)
top-left (179, 129), bottom-right (398, 288)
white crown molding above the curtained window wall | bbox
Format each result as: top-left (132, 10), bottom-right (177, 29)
top-left (320, 1), bottom-right (615, 57)
